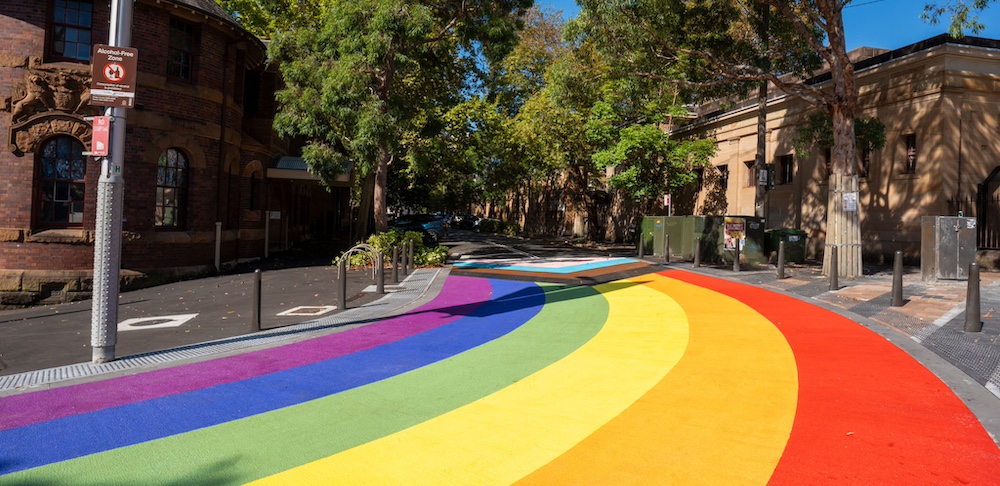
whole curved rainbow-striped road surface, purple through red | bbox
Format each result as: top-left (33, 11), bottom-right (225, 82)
top-left (0, 270), bottom-right (1000, 485)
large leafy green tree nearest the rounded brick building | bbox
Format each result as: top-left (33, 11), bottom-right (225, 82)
top-left (268, 0), bottom-right (532, 235)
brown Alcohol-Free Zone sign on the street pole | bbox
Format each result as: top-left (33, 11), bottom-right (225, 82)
top-left (90, 44), bottom-right (139, 108)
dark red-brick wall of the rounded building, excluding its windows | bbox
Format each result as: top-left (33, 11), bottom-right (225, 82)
top-left (0, 0), bottom-right (322, 305)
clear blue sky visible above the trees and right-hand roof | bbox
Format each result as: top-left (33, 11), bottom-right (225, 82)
top-left (535, 0), bottom-right (1000, 50)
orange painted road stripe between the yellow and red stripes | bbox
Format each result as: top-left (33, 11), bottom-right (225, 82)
top-left (520, 278), bottom-right (798, 485)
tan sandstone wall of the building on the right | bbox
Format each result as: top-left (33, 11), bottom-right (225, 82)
top-left (681, 42), bottom-right (1000, 261)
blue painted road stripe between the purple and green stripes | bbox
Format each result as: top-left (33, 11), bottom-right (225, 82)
top-left (0, 280), bottom-right (545, 474)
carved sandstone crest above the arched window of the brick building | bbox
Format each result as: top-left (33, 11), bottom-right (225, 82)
top-left (9, 66), bottom-right (98, 154)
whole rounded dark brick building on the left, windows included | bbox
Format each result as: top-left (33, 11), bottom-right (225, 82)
top-left (0, 0), bottom-right (347, 304)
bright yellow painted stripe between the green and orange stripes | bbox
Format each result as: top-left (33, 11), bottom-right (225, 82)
top-left (249, 275), bottom-right (688, 485)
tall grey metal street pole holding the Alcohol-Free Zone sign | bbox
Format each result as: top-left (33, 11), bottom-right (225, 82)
top-left (90, 0), bottom-right (134, 364)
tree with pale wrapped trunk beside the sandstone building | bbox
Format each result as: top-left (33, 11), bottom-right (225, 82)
top-left (582, 0), bottom-right (861, 277)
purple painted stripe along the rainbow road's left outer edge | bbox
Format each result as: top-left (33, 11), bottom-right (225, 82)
top-left (0, 277), bottom-right (492, 430)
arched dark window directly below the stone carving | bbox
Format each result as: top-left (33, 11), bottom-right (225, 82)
top-left (37, 136), bottom-right (87, 228)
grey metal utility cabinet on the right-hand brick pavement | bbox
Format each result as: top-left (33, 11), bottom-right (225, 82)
top-left (920, 216), bottom-right (976, 281)
